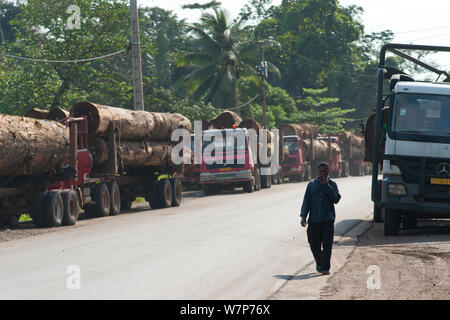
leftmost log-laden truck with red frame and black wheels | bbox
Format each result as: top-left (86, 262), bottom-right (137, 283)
top-left (0, 102), bottom-right (192, 227)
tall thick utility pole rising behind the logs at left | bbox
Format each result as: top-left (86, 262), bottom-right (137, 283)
top-left (130, 0), bottom-right (144, 110)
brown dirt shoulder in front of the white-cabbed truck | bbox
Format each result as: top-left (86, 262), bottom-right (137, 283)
top-left (320, 221), bottom-right (450, 300)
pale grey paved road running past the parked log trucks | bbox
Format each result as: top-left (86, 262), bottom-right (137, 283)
top-left (0, 176), bottom-right (371, 299)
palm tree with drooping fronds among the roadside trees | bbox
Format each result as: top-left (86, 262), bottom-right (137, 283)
top-left (178, 9), bottom-right (256, 108)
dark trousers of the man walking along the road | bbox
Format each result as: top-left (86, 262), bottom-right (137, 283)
top-left (307, 221), bottom-right (334, 271)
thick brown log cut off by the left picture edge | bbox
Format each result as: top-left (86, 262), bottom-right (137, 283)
top-left (0, 115), bottom-right (69, 176)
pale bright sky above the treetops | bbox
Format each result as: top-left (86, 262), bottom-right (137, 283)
top-left (138, 0), bottom-right (450, 70)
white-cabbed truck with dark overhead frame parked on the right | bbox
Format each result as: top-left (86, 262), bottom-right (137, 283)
top-left (365, 44), bottom-right (450, 235)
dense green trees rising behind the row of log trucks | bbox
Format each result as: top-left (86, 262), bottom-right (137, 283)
top-left (0, 0), bottom-right (398, 132)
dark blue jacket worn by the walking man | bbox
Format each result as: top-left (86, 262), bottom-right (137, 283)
top-left (300, 178), bottom-right (341, 223)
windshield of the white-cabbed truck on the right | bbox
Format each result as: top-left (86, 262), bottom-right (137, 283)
top-left (392, 93), bottom-right (450, 137)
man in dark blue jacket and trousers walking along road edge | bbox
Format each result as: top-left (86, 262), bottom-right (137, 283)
top-left (300, 163), bottom-right (341, 274)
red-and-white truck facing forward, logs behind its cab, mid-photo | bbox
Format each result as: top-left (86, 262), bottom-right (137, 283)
top-left (200, 111), bottom-right (282, 195)
